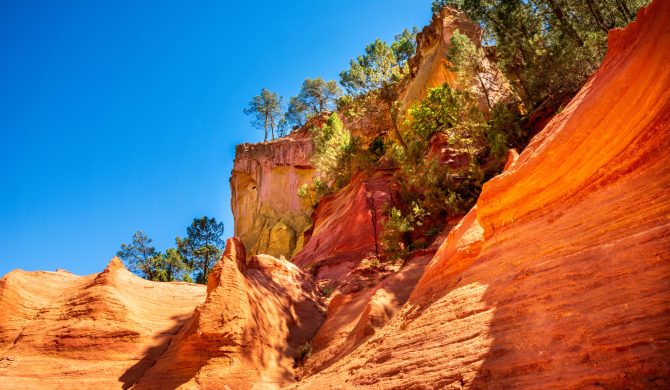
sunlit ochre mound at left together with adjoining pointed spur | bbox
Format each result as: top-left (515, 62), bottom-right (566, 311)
top-left (0, 238), bottom-right (325, 389)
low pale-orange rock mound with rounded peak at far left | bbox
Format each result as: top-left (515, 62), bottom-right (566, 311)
top-left (0, 259), bottom-right (205, 389)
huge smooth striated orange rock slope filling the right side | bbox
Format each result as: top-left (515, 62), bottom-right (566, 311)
top-left (299, 0), bottom-right (670, 389)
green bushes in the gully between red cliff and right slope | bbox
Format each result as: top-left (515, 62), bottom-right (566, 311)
top-left (383, 84), bottom-right (489, 260)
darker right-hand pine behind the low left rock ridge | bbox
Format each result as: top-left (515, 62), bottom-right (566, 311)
top-left (176, 217), bottom-right (225, 284)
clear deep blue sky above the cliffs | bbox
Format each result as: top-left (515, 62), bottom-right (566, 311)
top-left (0, 0), bottom-right (431, 276)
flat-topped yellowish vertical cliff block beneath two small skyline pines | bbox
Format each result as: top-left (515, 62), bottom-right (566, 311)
top-left (230, 131), bottom-right (316, 258)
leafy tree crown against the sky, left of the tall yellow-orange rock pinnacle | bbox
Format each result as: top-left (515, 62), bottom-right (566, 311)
top-left (340, 28), bottom-right (417, 96)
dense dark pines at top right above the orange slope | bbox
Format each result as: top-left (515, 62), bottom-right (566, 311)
top-left (456, 0), bottom-right (648, 109)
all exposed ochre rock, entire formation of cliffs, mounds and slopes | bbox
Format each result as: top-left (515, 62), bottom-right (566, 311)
top-left (0, 0), bottom-right (670, 389)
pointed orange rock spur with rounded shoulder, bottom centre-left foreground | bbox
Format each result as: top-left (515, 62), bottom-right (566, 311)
top-left (136, 238), bottom-right (325, 389)
